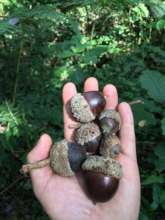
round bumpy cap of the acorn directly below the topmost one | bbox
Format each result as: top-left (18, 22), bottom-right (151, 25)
top-left (75, 122), bottom-right (101, 145)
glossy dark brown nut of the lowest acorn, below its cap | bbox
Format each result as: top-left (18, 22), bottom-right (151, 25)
top-left (83, 171), bottom-right (119, 202)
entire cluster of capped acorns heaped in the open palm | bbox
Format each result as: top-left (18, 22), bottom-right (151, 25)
top-left (22, 91), bottom-right (122, 202)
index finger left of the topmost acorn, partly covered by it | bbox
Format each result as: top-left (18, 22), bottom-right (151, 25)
top-left (63, 83), bottom-right (77, 140)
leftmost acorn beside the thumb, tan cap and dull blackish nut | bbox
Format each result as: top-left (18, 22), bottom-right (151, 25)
top-left (50, 139), bottom-right (86, 176)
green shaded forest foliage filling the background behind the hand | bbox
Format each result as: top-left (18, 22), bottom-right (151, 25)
top-left (0, 0), bottom-right (165, 220)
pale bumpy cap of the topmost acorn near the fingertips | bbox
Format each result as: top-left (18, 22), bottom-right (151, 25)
top-left (70, 93), bottom-right (96, 123)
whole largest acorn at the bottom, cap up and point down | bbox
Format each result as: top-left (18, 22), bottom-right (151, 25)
top-left (82, 156), bottom-right (122, 202)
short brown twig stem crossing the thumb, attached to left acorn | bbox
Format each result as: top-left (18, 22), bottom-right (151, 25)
top-left (20, 158), bottom-right (50, 174)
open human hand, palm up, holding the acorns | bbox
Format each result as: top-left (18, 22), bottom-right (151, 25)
top-left (28, 77), bottom-right (140, 220)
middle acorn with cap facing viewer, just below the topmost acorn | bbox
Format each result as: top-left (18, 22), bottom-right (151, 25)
top-left (74, 122), bottom-right (101, 154)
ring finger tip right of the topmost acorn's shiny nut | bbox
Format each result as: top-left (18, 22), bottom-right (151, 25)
top-left (103, 84), bottom-right (118, 109)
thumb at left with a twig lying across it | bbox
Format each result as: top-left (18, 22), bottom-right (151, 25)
top-left (27, 134), bottom-right (52, 184)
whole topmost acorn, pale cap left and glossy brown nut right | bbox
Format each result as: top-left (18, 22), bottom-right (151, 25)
top-left (70, 91), bottom-right (106, 123)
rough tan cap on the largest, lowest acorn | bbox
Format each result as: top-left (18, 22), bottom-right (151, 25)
top-left (82, 156), bottom-right (122, 179)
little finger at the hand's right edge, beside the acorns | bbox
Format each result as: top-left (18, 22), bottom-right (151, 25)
top-left (118, 102), bottom-right (136, 160)
